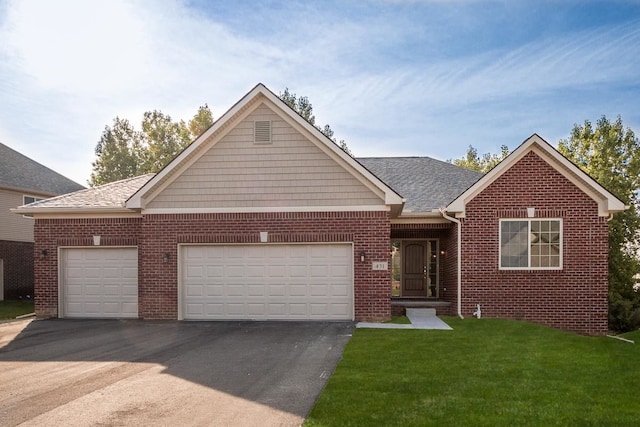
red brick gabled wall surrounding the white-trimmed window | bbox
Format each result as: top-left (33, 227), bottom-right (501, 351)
top-left (462, 152), bottom-right (608, 335)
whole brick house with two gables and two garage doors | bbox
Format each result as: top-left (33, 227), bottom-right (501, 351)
top-left (16, 85), bottom-right (625, 335)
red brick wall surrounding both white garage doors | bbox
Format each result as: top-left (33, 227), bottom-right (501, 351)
top-left (35, 212), bottom-right (391, 320)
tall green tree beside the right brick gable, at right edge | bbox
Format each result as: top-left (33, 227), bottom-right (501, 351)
top-left (558, 116), bottom-right (640, 331)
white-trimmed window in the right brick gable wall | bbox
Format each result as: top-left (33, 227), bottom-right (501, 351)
top-left (500, 219), bottom-right (562, 270)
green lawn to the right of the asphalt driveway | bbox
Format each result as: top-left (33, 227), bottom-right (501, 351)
top-left (305, 318), bottom-right (640, 427)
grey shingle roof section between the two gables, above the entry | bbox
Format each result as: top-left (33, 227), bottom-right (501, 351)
top-left (356, 157), bottom-right (482, 212)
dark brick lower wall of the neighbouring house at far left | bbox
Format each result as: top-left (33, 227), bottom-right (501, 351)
top-left (0, 240), bottom-right (33, 299)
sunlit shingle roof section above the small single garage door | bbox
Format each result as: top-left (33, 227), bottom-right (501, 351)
top-left (28, 173), bottom-right (154, 209)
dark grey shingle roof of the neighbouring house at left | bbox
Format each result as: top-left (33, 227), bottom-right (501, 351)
top-left (0, 143), bottom-right (84, 195)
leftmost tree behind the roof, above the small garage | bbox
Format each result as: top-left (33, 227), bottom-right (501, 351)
top-left (89, 117), bottom-right (143, 187)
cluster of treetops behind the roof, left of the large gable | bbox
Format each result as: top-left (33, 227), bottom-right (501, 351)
top-left (89, 104), bottom-right (213, 186)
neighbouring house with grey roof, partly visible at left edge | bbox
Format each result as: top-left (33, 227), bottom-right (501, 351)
top-left (0, 143), bottom-right (84, 300)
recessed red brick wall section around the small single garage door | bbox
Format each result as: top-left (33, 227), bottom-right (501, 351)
top-left (34, 218), bottom-right (141, 317)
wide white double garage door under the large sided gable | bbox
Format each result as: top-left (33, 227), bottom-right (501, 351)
top-left (180, 244), bottom-right (353, 320)
